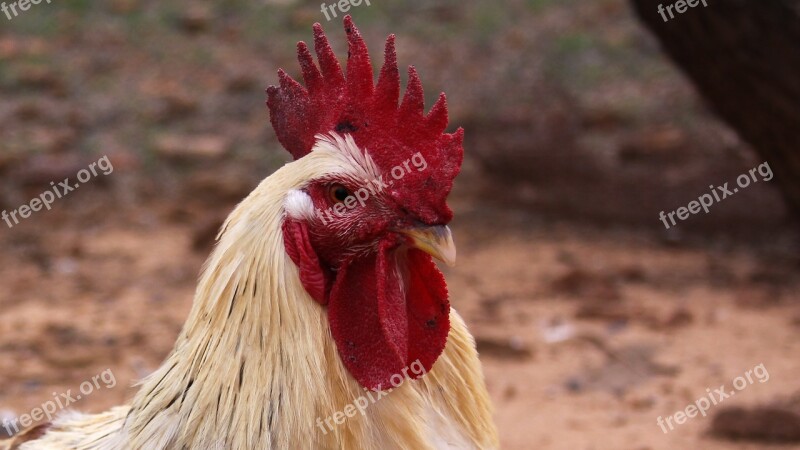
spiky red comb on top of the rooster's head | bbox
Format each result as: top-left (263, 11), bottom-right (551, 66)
top-left (267, 16), bottom-right (464, 223)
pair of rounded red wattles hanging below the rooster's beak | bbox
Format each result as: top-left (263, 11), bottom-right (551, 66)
top-left (328, 245), bottom-right (450, 390)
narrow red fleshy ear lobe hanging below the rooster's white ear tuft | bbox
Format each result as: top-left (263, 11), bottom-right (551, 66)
top-left (283, 217), bottom-right (333, 306)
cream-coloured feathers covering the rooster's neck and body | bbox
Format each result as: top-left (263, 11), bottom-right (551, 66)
top-left (0, 135), bottom-right (498, 450)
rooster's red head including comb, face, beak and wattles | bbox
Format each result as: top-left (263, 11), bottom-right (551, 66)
top-left (267, 16), bottom-right (463, 390)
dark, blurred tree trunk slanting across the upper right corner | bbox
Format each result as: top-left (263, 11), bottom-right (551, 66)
top-left (631, 0), bottom-right (800, 216)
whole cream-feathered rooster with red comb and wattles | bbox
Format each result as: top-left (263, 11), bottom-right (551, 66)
top-left (0, 16), bottom-right (498, 450)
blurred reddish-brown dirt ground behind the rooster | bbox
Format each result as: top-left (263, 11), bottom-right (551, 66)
top-left (0, 0), bottom-right (800, 450)
